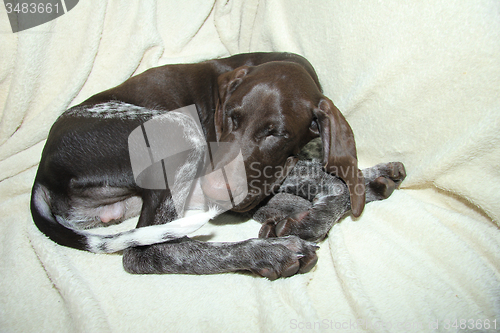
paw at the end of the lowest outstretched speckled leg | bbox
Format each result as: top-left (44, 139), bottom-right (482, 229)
top-left (250, 236), bottom-right (319, 280)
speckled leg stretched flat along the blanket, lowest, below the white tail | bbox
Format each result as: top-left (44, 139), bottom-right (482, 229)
top-left (123, 236), bottom-right (318, 280)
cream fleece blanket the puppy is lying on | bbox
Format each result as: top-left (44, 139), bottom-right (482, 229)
top-left (0, 0), bottom-right (500, 332)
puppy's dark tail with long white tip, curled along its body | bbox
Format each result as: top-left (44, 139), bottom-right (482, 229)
top-left (31, 182), bottom-right (221, 253)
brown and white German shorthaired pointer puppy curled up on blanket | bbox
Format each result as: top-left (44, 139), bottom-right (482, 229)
top-left (31, 53), bottom-right (402, 279)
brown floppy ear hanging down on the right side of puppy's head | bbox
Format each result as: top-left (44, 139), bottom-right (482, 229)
top-left (313, 97), bottom-right (365, 217)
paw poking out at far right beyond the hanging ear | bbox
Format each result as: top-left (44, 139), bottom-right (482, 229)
top-left (363, 162), bottom-right (406, 202)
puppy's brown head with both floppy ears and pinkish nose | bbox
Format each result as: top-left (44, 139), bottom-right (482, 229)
top-left (202, 61), bottom-right (365, 216)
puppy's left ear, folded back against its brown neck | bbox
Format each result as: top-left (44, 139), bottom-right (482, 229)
top-left (215, 66), bottom-right (250, 140)
